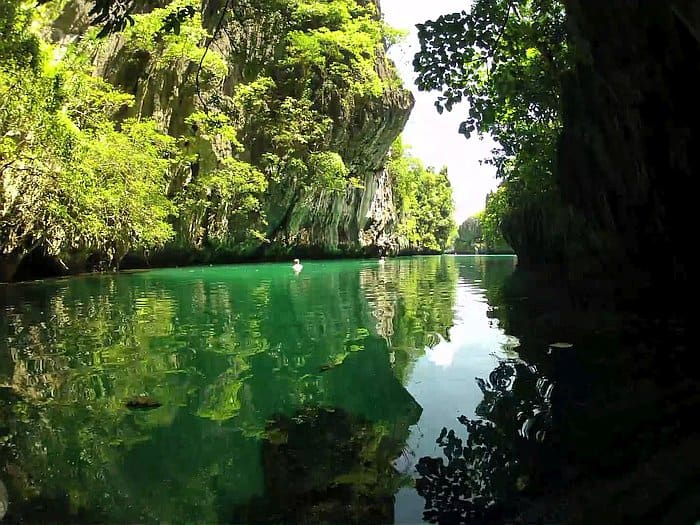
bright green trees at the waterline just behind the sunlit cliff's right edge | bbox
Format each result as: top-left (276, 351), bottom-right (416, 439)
top-left (387, 138), bottom-right (456, 252)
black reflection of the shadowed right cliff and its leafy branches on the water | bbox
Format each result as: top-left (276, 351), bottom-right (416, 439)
top-left (416, 272), bottom-right (700, 525)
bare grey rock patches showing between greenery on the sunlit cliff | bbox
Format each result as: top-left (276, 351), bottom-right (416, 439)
top-left (51, 0), bottom-right (413, 257)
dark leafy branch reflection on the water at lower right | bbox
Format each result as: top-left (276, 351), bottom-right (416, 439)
top-left (416, 359), bottom-right (553, 523)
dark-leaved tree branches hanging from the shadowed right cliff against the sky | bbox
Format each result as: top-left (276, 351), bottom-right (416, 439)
top-left (414, 0), bottom-right (571, 252)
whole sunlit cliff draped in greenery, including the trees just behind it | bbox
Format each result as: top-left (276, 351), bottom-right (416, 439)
top-left (0, 0), bottom-right (452, 280)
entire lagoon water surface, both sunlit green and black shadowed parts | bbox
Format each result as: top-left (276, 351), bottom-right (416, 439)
top-left (0, 256), bottom-right (700, 524)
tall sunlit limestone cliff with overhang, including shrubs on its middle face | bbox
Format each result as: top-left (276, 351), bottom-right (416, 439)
top-left (51, 0), bottom-right (413, 263)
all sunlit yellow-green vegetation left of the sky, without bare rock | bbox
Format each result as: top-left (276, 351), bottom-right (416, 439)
top-left (0, 0), bottom-right (453, 280)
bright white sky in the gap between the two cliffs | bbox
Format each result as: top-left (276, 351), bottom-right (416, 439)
top-left (381, 0), bottom-right (498, 224)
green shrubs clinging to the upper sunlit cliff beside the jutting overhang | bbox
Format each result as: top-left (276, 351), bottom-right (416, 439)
top-left (213, 0), bottom-right (393, 201)
